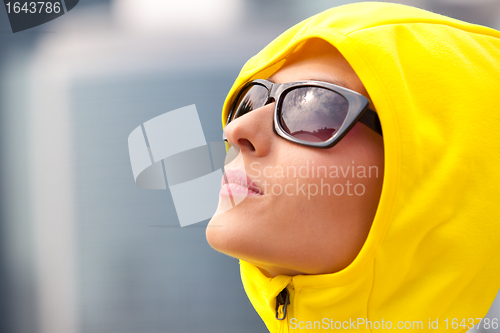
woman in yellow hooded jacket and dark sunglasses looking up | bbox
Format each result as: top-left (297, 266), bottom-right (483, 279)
top-left (207, 3), bottom-right (500, 332)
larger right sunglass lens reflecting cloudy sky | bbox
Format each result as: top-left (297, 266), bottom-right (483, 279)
top-left (280, 87), bottom-right (349, 142)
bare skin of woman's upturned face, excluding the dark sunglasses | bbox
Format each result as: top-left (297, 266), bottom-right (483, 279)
top-left (207, 40), bottom-right (384, 276)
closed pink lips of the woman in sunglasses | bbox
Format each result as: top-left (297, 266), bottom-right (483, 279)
top-left (220, 169), bottom-right (263, 197)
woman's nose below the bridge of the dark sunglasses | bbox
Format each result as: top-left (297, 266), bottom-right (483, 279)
top-left (224, 103), bottom-right (277, 157)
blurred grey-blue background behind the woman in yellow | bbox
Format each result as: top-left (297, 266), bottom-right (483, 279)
top-left (0, 0), bottom-right (500, 333)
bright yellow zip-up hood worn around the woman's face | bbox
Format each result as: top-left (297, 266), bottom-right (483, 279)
top-left (222, 3), bottom-right (500, 332)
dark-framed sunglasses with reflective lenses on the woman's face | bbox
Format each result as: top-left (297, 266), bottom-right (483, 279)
top-left (223, 79), bottom-right (382, 148)
